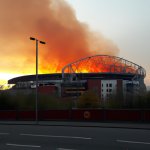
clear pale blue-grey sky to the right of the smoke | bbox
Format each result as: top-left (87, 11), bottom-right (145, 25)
top-left (67, 0), bottom-right (150, 85)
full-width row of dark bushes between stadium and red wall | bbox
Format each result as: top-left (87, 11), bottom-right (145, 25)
top-left (0, 90), bottom-right (150, 110)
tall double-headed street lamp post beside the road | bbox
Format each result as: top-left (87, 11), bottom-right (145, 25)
top-left (30, 37), bottom-right (46, 124)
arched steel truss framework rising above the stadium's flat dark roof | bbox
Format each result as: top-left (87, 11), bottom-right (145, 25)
top-left (62, 55), bottom-right (146, 78)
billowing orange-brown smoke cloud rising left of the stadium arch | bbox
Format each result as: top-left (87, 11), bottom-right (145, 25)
top-left (0, 0), bottom-right (119, 74)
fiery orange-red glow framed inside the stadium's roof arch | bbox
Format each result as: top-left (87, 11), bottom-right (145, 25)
top-left (64, 56), bottom-right (138, 74)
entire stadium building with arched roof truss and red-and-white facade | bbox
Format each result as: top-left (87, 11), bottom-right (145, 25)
top-left (8, 55), bottom-right (146, 100)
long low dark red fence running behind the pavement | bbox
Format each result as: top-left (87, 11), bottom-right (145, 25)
top-left (0, 109), bottom-right (150, 122)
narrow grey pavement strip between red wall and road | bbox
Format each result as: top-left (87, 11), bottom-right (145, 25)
top-left (0, 121), bottom-right (150, 130)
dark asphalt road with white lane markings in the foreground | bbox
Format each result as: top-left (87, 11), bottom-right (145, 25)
top-left (0, 125), bottom-right (150, 150)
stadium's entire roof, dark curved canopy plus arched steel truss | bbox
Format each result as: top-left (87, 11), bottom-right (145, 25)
top-left (8, 55), bottom-right (146, 84)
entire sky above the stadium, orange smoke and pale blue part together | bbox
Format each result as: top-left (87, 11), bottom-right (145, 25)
top-left (0, 0), bottom-right (150, 85)
